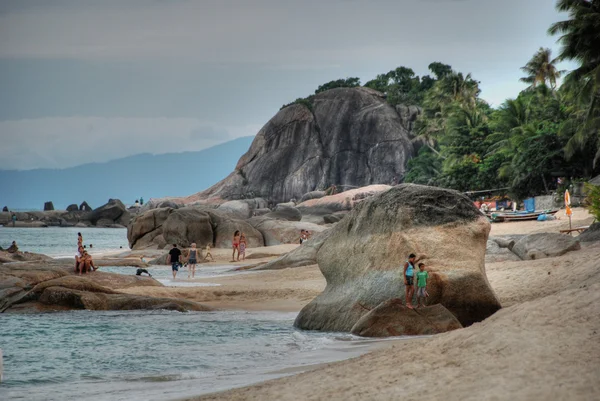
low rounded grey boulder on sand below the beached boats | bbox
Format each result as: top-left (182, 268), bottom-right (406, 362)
top-left (512, 233), bottom-right (581, 260)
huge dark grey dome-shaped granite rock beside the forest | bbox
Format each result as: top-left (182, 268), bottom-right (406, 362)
top-left (188, 87), bottom-right (413, 203)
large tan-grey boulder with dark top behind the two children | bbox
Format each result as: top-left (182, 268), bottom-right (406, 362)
top-left (295, 184), bottom-right (501, 331)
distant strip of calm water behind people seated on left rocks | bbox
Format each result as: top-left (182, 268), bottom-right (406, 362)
top-left (0, 227), bottom-right (129, 257)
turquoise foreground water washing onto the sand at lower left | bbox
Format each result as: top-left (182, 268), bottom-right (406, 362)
top-left (0, 311), bottom-right (376, 400)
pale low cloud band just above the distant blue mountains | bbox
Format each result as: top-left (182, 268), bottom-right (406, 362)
top-left (0, 117), bottom-right (258, 170)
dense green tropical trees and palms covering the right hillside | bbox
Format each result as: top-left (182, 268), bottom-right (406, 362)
top-left (283, 0), bottom-right (600, 199)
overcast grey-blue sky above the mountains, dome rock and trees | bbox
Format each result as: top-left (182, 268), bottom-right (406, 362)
top-left (0, 0), bottom-right (566, 170)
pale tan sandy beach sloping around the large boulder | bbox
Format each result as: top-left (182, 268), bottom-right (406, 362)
top-left (111, 209), bottom-right (600, 400)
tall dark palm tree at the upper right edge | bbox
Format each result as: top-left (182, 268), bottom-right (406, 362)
top-left (548, 0), bottom-right (600, 168)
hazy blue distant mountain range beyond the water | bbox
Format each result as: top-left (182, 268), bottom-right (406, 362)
top-left (0, 136), bottom-right (254, 210)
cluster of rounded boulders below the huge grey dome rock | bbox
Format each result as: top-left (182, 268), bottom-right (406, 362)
top-left (127, 185), bottom-right (390, 249)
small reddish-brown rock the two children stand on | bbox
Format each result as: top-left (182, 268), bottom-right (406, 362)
top-left (350, 298), bottom-right (463, 337)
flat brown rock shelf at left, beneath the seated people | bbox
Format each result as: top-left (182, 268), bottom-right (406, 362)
top-left (0, 262), bottom-right (210, 312)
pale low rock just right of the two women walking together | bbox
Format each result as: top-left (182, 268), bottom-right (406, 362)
top-left (248, 216), bottom-right (327, 246)
